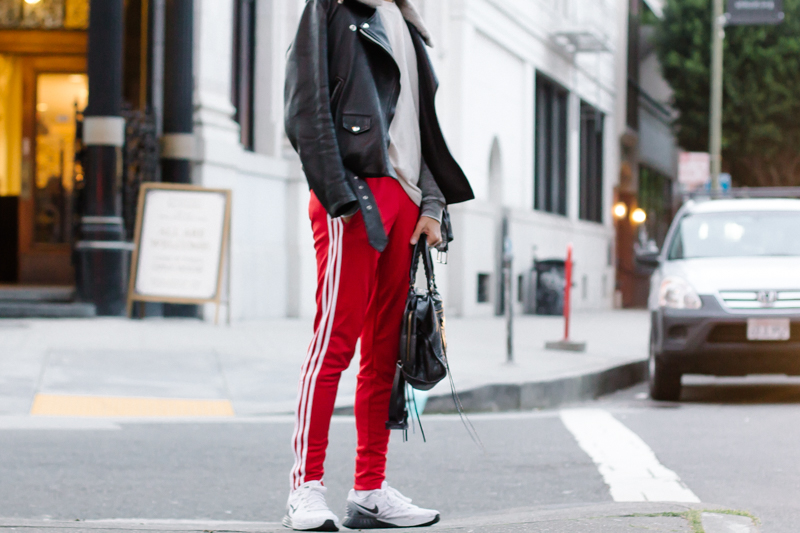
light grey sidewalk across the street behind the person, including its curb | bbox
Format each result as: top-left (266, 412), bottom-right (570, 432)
top-left (0, 311), bottom-right (649, 416)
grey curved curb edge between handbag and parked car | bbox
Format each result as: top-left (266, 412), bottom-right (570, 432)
top-left (422, 361), bottom-right (647, 413)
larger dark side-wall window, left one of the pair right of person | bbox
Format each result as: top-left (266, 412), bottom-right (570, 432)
top-left (534, 75), bottom-right (568, 215)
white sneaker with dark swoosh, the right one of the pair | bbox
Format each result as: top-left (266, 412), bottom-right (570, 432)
top-left (342, 481), bottom-right (439, 529)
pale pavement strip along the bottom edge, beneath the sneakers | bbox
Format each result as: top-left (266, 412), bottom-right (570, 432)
top-left (0, 503), bottom-right (758, 533)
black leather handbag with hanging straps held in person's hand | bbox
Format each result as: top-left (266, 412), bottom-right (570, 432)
top-left (386, 239), bottom-right (448, 429)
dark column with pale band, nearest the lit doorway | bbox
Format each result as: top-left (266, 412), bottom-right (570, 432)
top-left (75, 0), bottom-right (131, 316)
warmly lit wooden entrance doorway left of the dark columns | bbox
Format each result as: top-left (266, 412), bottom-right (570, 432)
top-left (0, 54), bottom-right (89, 285)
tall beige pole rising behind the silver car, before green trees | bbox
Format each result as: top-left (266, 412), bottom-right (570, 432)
top-left (708, 0), bottom-right (725, 194)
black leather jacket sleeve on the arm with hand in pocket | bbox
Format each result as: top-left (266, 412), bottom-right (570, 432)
top-left (284, 0), bottom-right (357, 217)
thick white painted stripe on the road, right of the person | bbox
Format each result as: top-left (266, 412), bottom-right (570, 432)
top-left (561, 409), bottom-right (700, 502)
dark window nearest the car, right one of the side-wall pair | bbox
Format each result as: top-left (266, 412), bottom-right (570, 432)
top-left (579, 102), bottom-right (605, 222)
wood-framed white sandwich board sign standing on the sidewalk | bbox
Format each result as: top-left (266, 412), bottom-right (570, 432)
top-left (128, 183), bottom-right (231, 322)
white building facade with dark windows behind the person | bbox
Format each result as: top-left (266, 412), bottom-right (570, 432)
top-left (0, 0), bottom-right (627, 320)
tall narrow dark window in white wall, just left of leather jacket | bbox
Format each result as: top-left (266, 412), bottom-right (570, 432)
top-left (231, 0), bottom-right (256, 150)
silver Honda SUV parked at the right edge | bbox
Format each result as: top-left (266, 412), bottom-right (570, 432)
top-left (637, 198), bottom-right (800, 401)
